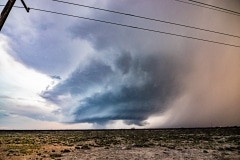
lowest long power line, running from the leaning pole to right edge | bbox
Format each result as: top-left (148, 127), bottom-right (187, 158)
top-left (1, 6), bottom-right (240, 48)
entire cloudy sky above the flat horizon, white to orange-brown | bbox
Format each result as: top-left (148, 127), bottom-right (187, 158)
top-left (0, 0), bottom-right (240, 129)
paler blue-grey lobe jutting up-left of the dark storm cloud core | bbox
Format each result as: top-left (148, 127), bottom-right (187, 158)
top-left (41, 61), bottom-right (113, 103)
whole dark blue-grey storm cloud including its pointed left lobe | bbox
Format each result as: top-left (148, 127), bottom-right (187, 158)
top-left (42, 52), bottom-right (180, 125)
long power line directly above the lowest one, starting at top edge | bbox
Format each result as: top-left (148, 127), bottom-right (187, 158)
top-left (52, 0), bottom-right (240, 38)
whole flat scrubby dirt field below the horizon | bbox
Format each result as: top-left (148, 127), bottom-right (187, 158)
top-left (0, 127), bottom-right (240, 160)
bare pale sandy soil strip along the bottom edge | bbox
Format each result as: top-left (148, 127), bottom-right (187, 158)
top-left (4, 147), bottom-right (240, 160)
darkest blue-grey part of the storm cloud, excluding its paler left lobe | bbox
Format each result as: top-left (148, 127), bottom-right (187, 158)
top-left (73, 53), bottom-right (180, 125)
